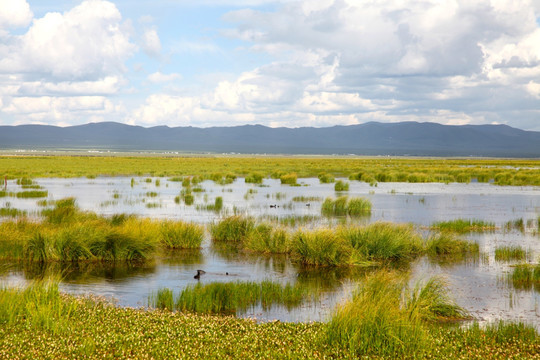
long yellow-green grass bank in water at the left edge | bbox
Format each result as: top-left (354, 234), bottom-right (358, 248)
top-left (0, 199), bottom-right (204, 262)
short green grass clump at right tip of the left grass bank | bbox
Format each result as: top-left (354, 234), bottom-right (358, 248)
top-left (160, 221), bottom-right (204, 249)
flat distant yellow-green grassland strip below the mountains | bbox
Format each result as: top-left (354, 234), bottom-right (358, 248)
top-left (0, 156), bottom-right (540, 185)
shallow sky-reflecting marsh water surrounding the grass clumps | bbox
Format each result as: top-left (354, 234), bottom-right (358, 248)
top-left (0, 177), bottom-right (540, 327)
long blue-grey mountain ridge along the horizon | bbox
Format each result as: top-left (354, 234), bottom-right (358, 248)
top-left (0, 122), bottom-right (540, 157)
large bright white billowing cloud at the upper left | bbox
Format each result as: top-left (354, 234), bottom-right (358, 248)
top-left (0, 0), bottom-right (135, 80)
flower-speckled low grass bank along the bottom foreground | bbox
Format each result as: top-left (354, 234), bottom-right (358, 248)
top-left (0, 284), bottom-right (540, 359)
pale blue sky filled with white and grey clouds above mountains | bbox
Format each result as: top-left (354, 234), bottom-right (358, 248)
top-left (0, 0), bottom-right (540, 131)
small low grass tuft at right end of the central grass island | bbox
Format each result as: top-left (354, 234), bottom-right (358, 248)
top-left (426, 232), bottom-right (480, 258)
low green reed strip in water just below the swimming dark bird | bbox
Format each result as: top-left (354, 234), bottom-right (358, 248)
top-left (154, 280), bottom-right (308, 314)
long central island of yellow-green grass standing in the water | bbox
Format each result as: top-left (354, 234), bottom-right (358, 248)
top-left (210, 216), bottom-right (479, 266)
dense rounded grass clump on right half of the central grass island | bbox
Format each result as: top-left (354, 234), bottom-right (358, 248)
top-left (340, 222), bottom-right (423, 264)
